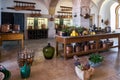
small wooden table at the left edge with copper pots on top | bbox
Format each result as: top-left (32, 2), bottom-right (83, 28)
top-left (0, 33), bottom-right (24, 48)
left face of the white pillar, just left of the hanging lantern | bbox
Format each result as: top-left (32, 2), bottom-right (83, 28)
top-left (72, 0), bottom-right (81, 26)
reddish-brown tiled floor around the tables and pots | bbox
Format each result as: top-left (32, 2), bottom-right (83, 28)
top-left (0, 39), bottom-right (120, 80)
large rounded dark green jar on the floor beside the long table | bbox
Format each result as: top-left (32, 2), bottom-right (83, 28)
top-left (43, 43), bottom-right (55, 59)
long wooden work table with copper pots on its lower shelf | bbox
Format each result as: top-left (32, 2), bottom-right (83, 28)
top-left (56, 33), bottom-right (120, 59)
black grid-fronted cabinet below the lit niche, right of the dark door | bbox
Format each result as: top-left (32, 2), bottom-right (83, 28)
top-left (27, 29), bottom-right (48, 39)
